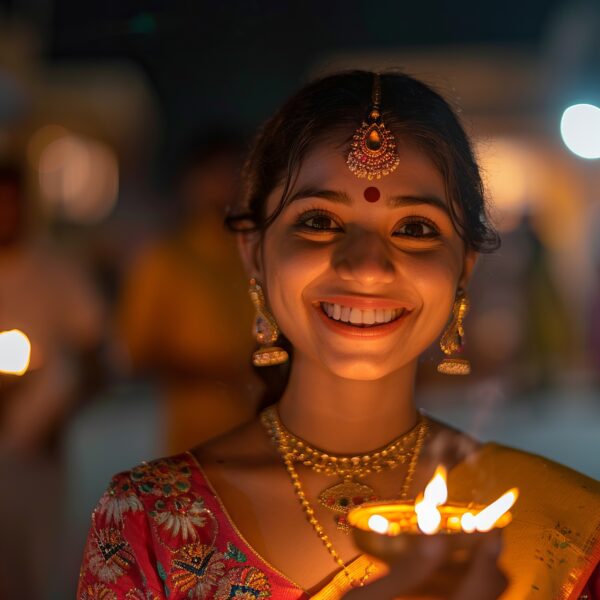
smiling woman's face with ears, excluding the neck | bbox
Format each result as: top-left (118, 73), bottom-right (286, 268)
top-left (241, 145), bottom-right (475, 380)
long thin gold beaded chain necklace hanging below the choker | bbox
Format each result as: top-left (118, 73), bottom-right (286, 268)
top-left (261, 406), bottom-right (429, 587)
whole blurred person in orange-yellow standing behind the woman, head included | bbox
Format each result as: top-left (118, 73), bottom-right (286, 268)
top-left (119, 131), bottom-right (255, 452)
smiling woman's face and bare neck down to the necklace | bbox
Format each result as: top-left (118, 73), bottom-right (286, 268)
top-left (241, 143), bottom-right (475, 453)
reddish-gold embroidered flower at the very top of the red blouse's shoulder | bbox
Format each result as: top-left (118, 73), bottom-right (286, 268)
top-left (131, 458), bottom-right (192, 497)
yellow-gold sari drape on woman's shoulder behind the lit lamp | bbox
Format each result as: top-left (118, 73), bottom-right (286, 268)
top-left (312, 443), bottom-right (600, 600)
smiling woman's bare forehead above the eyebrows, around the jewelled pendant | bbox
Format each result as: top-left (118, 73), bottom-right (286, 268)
top-left (293, 143), bottom-right (447, 201)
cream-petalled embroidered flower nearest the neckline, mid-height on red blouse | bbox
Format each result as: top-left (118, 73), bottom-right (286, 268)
top-left (150, 496), bottom-right (206, 542)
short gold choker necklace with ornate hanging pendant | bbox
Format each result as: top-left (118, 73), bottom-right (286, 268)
top-left (261, 406), bottom-right (429, 533)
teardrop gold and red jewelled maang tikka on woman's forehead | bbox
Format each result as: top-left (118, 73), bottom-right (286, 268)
top-left (346, 73), bottom-right (400, 180)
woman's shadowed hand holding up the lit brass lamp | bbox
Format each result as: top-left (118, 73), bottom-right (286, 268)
top-left (344, 530), bottom-right (508, 600)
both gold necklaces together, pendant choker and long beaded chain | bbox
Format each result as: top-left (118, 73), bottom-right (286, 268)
top-left (261, 406), bottom-right (429, 586)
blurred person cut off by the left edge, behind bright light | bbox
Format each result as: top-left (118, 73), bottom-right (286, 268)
top-left (0, 165), bottom-right (105, 599)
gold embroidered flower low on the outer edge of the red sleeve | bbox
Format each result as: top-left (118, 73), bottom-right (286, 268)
top-left (89, 528), bottom-right (134, 583)
